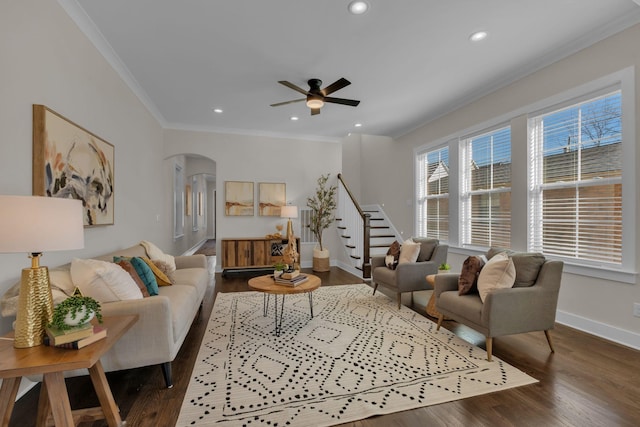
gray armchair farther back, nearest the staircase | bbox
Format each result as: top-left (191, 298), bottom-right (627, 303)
top-left (371, 237), bottom-right (449, 309)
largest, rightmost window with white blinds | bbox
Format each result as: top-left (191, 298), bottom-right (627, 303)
top-left (529, 90), bottom-right (623, 265)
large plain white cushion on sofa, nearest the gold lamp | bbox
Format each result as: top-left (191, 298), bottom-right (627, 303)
top-left (71, 258), bottom-right (142, 303)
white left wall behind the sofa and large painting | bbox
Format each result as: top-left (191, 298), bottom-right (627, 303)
top-left (0, 0), bottom-right (171, 333)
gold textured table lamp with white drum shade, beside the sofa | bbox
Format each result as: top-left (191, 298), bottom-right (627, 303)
top-left (0, 196), bottom-right (84, 348)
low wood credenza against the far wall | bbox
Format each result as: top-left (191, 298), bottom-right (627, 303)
top-left (222, 237), bottom-right (300, 274)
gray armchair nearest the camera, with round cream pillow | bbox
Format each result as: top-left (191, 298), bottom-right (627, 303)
top-left (434, 249), bottom-right (564, 361)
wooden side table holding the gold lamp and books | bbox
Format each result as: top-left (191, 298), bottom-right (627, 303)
top-left (0, 315), bottom-right (138, 427)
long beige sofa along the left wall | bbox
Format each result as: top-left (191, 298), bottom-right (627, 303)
top-left (3, 245), bottom-right (213, 388)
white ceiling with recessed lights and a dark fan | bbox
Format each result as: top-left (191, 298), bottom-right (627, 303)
top-left (63, 0), bottom-right (640, 140)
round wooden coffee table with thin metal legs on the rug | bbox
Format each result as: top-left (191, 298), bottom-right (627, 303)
top-left (249, 273), bottom-right (322, 337)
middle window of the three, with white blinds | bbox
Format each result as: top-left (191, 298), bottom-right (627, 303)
top-left (460, 127), bottom-right (511, 248)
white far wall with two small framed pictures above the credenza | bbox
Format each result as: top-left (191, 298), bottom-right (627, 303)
top-left (164, 129), bottom-right (343, 270)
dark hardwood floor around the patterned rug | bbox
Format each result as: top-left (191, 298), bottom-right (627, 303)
top-left (10, 267), bottom-right (640, 427)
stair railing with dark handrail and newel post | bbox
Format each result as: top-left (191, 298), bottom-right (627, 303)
top-left (337, 174), bottom-right (371, 279)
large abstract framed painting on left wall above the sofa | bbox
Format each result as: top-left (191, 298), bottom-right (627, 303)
top-left (32, 104), bottom-right (115, 227)
